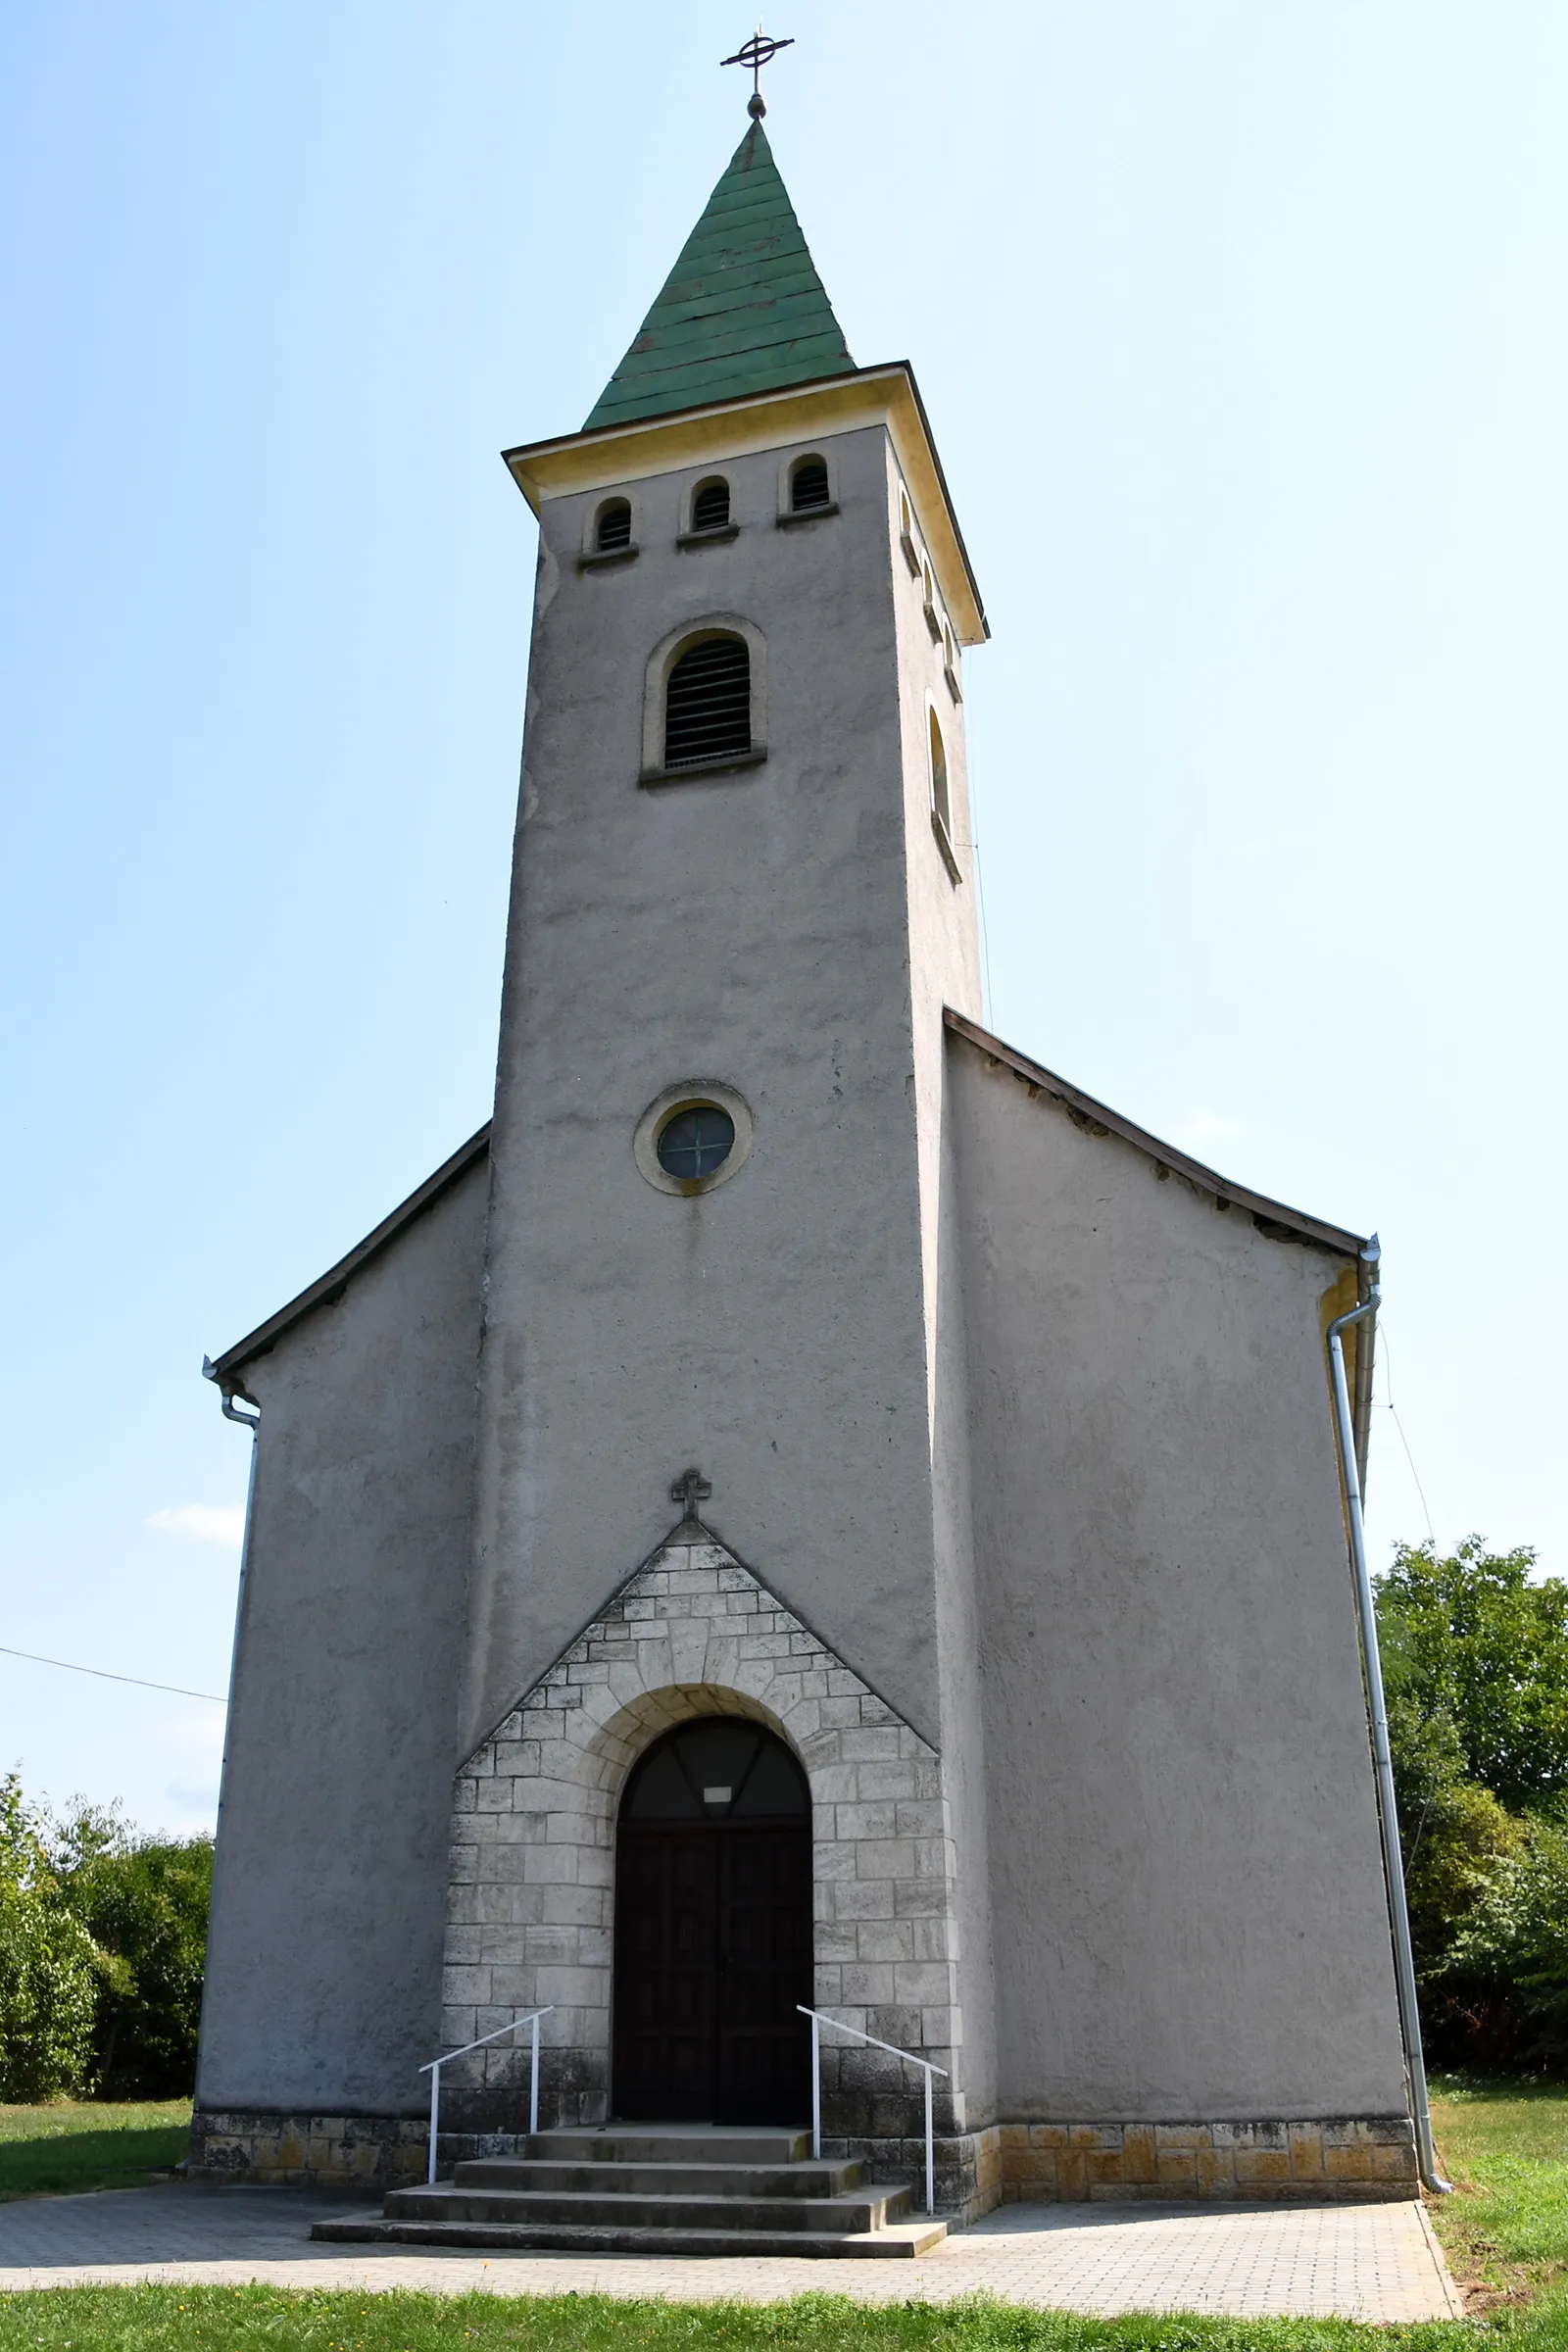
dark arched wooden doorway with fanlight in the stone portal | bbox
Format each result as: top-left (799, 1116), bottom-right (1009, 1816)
top-left (613, 1715), bottom-right (811, 2124)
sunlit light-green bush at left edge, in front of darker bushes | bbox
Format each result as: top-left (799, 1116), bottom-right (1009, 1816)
top-left (0, 1774), bottom-right (101, 2103)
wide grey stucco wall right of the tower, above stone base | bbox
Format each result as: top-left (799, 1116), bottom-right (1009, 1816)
top-left (948, 1035), bottom-right (1403, 2122)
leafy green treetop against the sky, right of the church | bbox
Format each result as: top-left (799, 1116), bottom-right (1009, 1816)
top-left (1378, 1536), bottom-right (1568, 1813)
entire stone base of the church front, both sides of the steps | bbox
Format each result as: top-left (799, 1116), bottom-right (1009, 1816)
top-left (190, 2110), bottom-right (1420, 2223)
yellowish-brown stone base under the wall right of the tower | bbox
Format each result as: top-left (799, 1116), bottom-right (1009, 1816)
top-left (999, 2115), bottom-right (1420, 2204)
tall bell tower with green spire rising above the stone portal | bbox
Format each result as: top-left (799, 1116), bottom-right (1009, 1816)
top-left (461, 120), bottom-right (990, 2164)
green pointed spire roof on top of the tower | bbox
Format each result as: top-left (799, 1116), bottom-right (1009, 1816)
top-left (583, 122), bottom-right (856, 433)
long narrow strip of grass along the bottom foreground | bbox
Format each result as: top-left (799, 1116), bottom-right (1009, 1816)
top-left (0, 2286), bottom-right (1494, 2352)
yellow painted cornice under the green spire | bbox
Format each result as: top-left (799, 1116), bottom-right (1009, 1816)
top-left (503, 360), bottom-right (990, 645)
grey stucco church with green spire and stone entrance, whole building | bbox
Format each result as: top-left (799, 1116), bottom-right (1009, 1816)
top-left (195, 108), bottom-right (1415, 2241)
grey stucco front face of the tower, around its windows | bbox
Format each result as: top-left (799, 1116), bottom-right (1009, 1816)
top-left (466, 425), bottom-right (982, 1740)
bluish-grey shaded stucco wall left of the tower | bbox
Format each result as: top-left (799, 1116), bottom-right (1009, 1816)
top-left (197, 1159), bottom-right (489, 2115)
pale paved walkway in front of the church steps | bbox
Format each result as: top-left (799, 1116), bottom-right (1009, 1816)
top-left (0, 2182), bottom-right (1464, 2324)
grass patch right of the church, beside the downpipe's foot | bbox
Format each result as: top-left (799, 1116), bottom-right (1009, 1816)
top-left (1432, 2077), bottom-right (1568, 2314)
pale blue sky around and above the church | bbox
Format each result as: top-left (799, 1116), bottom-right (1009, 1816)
top-left (0, 0), bottom-right (1568, 1828)
